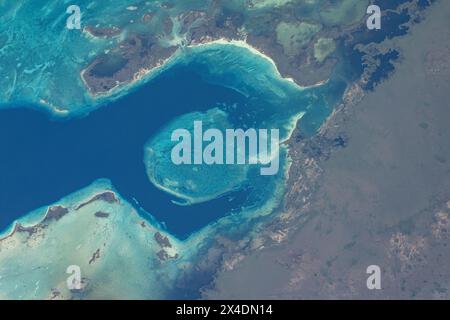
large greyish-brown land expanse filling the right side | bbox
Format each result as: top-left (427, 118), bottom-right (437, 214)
top-left (204, 1), bottom-right (450, 299)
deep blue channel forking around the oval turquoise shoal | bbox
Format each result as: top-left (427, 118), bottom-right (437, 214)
top-left (0, 67), bottom-right (250, 238)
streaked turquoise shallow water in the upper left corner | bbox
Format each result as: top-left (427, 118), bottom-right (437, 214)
top-left (0, 0), bottom-right (322, 116)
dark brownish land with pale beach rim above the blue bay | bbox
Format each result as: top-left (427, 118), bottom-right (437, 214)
top-left (82, 0), bottom-right (369, 95)
